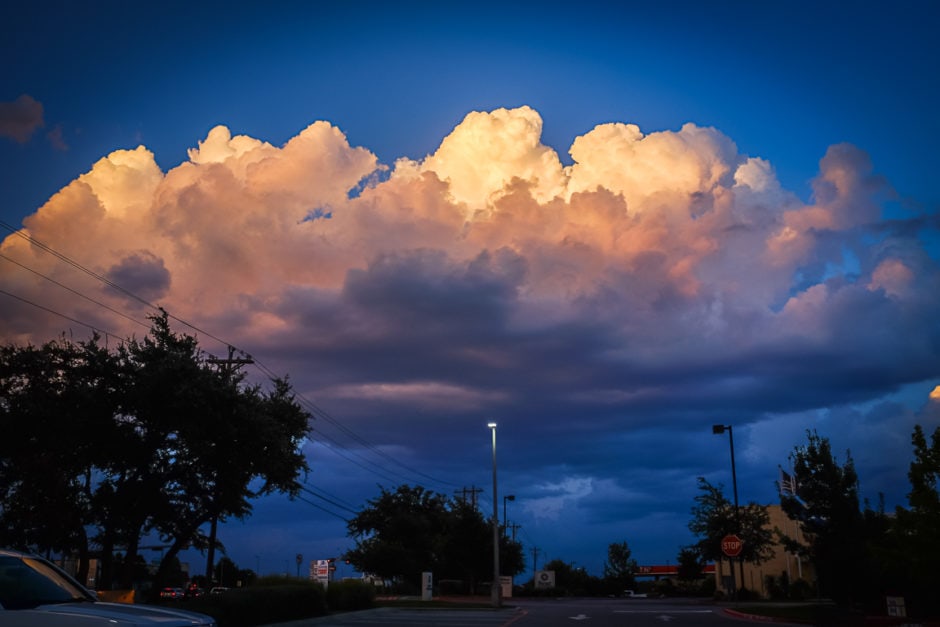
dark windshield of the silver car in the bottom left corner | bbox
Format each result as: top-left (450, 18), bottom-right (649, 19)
top-left (0, 555), bottom-right (92, 610)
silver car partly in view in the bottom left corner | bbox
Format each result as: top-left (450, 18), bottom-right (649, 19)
top-left (0, 549), bottom-right (216, 627)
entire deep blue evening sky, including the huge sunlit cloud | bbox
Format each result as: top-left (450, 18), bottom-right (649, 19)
top-left (0, 0), bottom-right (940, 576)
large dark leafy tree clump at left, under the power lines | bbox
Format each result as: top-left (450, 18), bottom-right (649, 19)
top-left (0, 313), bottom-right (309, 588)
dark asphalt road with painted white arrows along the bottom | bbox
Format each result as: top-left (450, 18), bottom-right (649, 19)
top-left (264, 598), bottom-right (800, 627)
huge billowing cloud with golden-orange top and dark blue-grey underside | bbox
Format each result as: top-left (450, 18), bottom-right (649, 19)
top-left (0, 103), bottom-right (940, 516)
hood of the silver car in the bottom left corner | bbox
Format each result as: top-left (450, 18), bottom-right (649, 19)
top-left (33, 602), bottom-right (215, 627)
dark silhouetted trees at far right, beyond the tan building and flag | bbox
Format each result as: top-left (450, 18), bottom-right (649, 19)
top-left (781, 425), bottom-right (940, 616)
